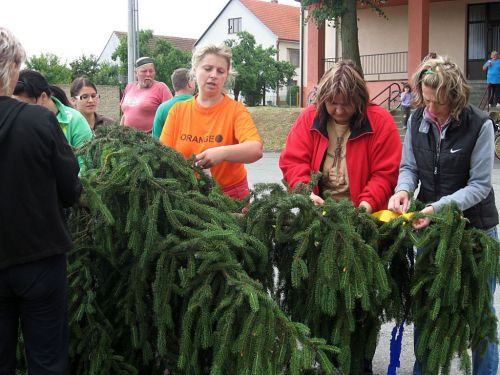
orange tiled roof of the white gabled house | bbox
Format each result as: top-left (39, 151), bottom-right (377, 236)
top-left (240, 0), bottom-right (300, 42)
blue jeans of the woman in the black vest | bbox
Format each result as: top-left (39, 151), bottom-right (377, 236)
top-left (413, 227), bottom-right (498, 375)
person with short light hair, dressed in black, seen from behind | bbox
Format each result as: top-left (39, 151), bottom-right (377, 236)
top-left (0, 27), bottom-right (82, 375)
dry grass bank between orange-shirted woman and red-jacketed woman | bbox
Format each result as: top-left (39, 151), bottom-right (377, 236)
top-left (248, 106), bottom-right (301, 152)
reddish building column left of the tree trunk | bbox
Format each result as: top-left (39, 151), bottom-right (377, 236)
top-left (303, 15), bottom-right (325, 106)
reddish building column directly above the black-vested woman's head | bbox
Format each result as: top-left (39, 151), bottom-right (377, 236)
top-left (408, 0), bottom-right (430, 79)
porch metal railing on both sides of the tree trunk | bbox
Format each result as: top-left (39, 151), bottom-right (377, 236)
top-left (325, 52), bottom-right (408, 76)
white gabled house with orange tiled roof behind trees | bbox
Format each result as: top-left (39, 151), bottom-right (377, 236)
top-left (195, 0), bottom-right (300, 104)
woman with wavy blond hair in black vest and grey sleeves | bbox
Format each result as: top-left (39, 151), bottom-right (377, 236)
top-left (388, 56), bottom-right (498, 374)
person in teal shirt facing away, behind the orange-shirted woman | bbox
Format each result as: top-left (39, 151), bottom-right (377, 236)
top-left (153, 68), bottom-right (196, 139)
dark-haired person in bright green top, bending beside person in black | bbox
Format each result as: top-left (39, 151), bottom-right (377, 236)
top-left (14, 70), bottom-right (92, 149)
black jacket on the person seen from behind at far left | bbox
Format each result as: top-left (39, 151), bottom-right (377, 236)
top-left (0, 96), bottom-right (82, 270)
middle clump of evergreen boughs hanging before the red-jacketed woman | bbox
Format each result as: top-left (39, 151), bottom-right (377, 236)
top-left (246, 185), bottom-right (391, 374)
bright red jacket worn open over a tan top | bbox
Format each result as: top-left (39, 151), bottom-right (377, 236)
top-left (279, 104), bottom-right (402, 212)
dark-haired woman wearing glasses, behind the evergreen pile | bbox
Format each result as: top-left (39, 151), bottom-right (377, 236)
top-left (69, 76), bottom-right (115, 131)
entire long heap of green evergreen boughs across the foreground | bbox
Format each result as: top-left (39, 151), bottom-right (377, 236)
top-left (13, 126), bottom-right (500, 375)
